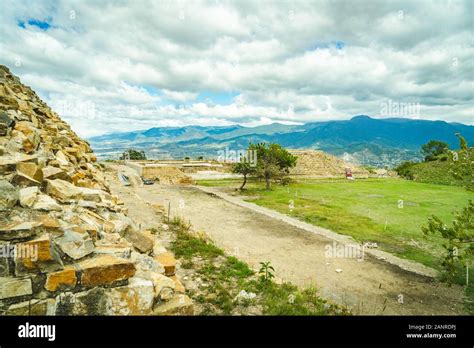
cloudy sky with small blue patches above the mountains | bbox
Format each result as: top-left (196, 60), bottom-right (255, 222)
top-left (0, 0), bottom-right (474, 136)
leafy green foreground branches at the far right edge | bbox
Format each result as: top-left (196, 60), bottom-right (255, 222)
top-left (422, 134), bottom-right (474, 283)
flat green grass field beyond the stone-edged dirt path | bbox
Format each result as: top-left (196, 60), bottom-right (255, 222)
top-left (194, 179), bottom-right (474, 284)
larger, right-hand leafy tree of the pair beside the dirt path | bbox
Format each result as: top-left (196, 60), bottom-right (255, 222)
top-left (253, 143), bottom-right (297, 190)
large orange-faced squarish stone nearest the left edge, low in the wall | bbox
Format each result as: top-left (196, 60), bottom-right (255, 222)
top-left (15, 234), bottom-right (63, 274)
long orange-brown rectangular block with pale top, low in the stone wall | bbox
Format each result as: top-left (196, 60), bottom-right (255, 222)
top-left (78, 255), bottom-right (135, 287)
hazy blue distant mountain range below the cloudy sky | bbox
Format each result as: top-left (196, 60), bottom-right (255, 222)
top-left (88, 115), bottom-right (474, 167)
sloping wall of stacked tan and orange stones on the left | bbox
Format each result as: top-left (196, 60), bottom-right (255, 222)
top-left (0, 65), bottom-right (193, 315)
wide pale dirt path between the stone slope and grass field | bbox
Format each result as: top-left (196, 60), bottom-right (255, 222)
top-left (108, 165), bottom-right (464, 315)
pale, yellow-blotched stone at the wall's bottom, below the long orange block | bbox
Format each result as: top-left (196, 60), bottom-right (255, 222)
top-left (107, 277), bottom-right (154, 315)
